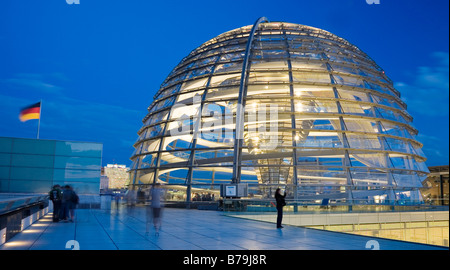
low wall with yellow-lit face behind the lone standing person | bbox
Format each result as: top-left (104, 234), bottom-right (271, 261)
top-left (220, 199), bottom-right (449, 247)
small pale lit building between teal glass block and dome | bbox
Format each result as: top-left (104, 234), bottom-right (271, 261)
top-left (100, 164), bottom-right (129, 190)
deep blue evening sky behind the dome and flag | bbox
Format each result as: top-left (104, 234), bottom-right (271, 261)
top-left (0, 0), bottom-right (449, 166)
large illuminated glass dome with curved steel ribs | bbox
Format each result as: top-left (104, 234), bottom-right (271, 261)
top-left (130, 18), bottom-right (428, 203)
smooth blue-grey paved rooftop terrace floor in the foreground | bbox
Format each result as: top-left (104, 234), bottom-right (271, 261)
top-left (0, 207), bottom-right (448, 250)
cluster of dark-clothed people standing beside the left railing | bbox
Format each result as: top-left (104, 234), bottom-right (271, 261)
top-left (49, 185), bottom-right (79, 222)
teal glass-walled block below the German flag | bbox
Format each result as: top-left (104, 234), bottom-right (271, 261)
top-left (0, 137), bottom-right (103, 195)
